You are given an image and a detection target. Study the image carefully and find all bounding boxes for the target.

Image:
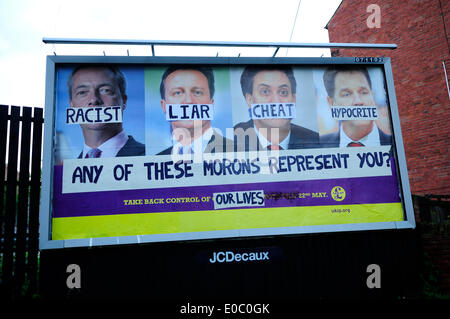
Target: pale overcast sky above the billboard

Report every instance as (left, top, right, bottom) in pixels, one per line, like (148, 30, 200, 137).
(0, 0, 341, 107)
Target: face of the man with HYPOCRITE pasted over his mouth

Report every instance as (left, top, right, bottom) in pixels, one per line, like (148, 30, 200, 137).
(328, 71, 375, 129)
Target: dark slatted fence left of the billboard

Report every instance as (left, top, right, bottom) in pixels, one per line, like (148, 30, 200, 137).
(0, 105, 44, 300)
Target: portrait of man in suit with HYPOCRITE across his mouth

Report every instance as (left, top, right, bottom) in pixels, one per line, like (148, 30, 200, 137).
(320, 66, 392, 147)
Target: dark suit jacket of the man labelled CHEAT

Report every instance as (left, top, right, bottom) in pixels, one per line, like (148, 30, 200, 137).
(234, 120, 320, 152)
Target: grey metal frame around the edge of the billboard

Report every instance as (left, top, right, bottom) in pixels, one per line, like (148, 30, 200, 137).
(39, 56, 415, 249)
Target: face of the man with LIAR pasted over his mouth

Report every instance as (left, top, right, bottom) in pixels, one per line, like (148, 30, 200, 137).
(161, 70, 214, 129)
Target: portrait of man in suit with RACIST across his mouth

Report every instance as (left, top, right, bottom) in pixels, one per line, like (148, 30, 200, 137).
(67, 65, 145, 158)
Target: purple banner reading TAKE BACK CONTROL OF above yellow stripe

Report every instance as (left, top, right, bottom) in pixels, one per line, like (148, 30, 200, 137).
(53, 162, 401, 217)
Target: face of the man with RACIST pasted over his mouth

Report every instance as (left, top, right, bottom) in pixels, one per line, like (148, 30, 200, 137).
(70, 68, 127, 129)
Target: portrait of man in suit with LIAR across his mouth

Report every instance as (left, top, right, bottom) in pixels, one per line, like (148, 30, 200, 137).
(157, 65, 233, 155)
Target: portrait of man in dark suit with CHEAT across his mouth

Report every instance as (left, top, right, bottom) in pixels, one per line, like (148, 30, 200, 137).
(234, 65, 319, 151)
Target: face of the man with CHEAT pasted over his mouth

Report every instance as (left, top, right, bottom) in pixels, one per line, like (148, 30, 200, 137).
(245, 71, 296, 128)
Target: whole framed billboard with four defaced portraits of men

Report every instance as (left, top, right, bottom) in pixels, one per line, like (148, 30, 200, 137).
(40, 56, 415, 249)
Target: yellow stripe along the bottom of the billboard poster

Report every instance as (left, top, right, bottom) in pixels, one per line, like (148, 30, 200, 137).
(52, 203, 404, 240)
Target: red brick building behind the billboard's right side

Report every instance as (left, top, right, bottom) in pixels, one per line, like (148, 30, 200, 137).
(326, 0, 450, 195)
